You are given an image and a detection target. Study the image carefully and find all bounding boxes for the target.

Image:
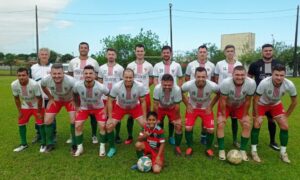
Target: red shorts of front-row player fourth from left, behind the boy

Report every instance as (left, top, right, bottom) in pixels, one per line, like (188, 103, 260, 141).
(112, 104, 143, 121)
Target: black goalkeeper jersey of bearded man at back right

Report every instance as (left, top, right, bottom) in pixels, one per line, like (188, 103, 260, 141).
(248, 59, 281, 85)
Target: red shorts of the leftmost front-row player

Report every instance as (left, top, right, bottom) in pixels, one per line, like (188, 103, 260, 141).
(18, 109, 45, 125)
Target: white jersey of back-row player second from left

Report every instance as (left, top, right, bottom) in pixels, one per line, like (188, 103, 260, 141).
(68, 57, 99, 81)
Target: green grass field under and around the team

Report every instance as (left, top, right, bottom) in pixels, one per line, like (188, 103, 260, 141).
(0, 76, 300, 179)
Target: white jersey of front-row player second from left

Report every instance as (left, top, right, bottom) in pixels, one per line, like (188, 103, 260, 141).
(41, 75, 76, 102)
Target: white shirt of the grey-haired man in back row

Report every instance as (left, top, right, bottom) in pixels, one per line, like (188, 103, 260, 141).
(30, 63, 52, 99)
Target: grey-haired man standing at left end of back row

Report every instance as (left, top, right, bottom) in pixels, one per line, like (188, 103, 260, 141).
(29, 48, 56, 143)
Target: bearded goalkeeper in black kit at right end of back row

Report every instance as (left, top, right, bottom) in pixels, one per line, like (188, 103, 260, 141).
(248, 44, 280, 151)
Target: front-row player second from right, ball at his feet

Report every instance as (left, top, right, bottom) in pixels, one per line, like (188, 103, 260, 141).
(217, 66, 256, 161)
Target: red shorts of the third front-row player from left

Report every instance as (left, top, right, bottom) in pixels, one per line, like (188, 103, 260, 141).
(75, 108, 107, 122)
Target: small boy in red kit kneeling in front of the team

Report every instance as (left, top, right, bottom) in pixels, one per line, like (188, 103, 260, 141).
(131, 112, 165, 173)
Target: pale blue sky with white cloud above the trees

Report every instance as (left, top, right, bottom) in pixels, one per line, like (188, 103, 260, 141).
(0, 0, 300, 56)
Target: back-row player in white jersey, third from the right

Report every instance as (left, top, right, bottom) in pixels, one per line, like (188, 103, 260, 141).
(185, 45, 215, 144)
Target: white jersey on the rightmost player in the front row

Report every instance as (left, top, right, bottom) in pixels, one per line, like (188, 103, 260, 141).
(256, 77, 297, 105)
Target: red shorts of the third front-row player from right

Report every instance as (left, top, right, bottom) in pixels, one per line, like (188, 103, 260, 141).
(185, 109, 214, 129)
